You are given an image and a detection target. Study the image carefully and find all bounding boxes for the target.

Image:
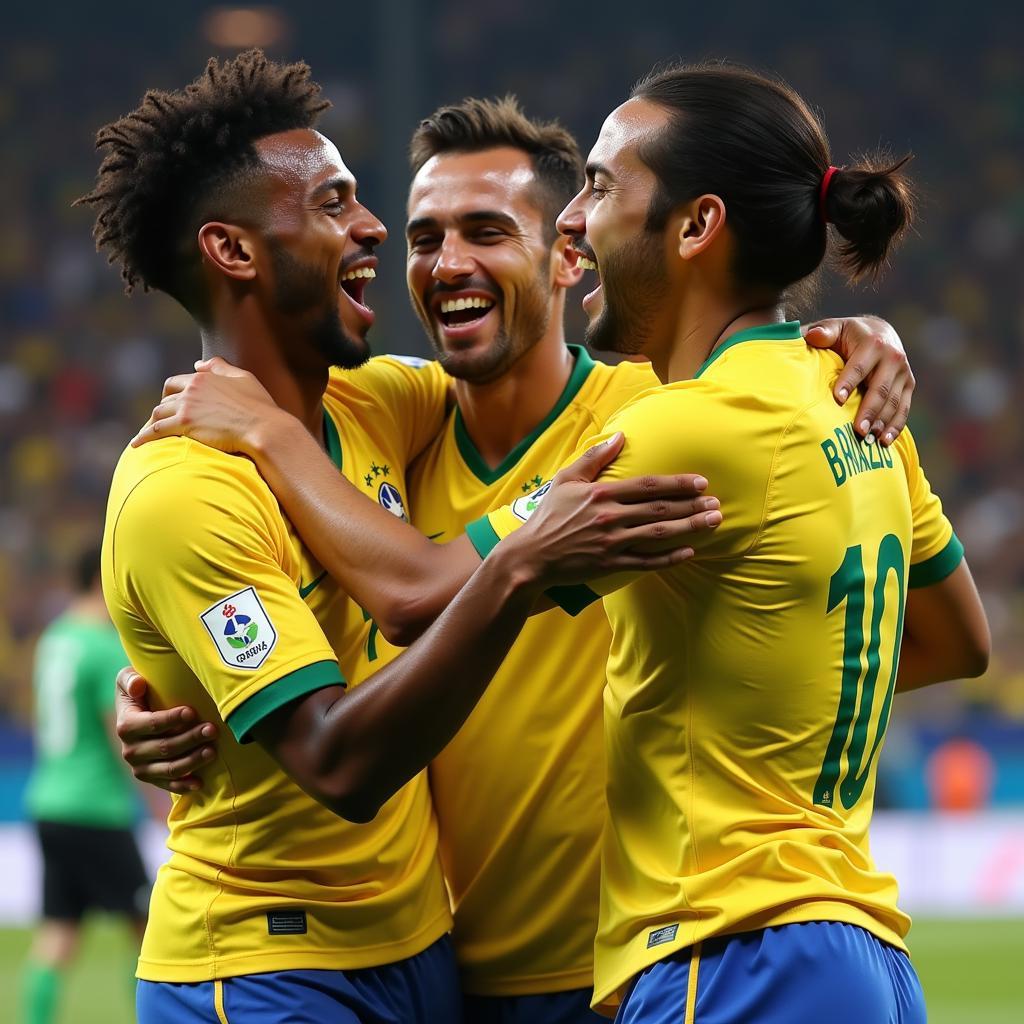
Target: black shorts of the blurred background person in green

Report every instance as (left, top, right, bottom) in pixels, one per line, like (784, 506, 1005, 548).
(36, 821, 150, 921)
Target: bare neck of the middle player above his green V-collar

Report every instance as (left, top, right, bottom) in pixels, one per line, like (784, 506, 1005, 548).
(455, 329, 573, 469)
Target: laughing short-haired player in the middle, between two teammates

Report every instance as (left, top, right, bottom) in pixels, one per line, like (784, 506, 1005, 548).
(117, 100, 921, 1022)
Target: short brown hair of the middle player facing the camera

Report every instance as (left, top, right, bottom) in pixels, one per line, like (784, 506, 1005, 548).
(409, 95, 584, 241)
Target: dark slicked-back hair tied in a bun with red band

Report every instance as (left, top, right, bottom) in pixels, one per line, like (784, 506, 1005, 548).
(631, 63, 913, 291)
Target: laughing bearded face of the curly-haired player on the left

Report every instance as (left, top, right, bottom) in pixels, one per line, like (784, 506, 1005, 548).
(256, 129, 387, 368)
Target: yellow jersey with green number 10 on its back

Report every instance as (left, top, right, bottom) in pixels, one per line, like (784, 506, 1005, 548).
(474, 323, 963, 1007)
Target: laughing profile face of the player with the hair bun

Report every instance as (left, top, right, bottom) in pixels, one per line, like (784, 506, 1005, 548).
(558, 99, 671, 356)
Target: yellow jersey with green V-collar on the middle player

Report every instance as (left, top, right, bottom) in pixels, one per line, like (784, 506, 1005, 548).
(399, 346, 656, 995)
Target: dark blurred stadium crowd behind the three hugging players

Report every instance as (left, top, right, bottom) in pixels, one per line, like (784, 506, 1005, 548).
(0, 0, 1024, 820)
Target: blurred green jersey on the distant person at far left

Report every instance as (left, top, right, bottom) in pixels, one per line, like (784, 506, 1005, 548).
(27, 612, 137, 828)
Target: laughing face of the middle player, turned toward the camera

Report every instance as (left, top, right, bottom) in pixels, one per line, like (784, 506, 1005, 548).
(407, 147, 554, 383)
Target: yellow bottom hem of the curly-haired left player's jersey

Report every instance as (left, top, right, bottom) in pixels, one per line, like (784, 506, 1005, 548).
(135, 910, 452, 984)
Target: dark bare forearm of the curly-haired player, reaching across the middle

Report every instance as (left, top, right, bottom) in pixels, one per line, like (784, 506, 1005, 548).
(299, 550, 538, 820)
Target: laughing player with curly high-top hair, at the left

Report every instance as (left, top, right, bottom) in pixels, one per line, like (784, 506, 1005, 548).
(82, 51, 707, 1024)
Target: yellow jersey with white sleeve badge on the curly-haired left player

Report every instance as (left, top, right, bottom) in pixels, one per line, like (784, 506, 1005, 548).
(102, 359, 452, 982)
